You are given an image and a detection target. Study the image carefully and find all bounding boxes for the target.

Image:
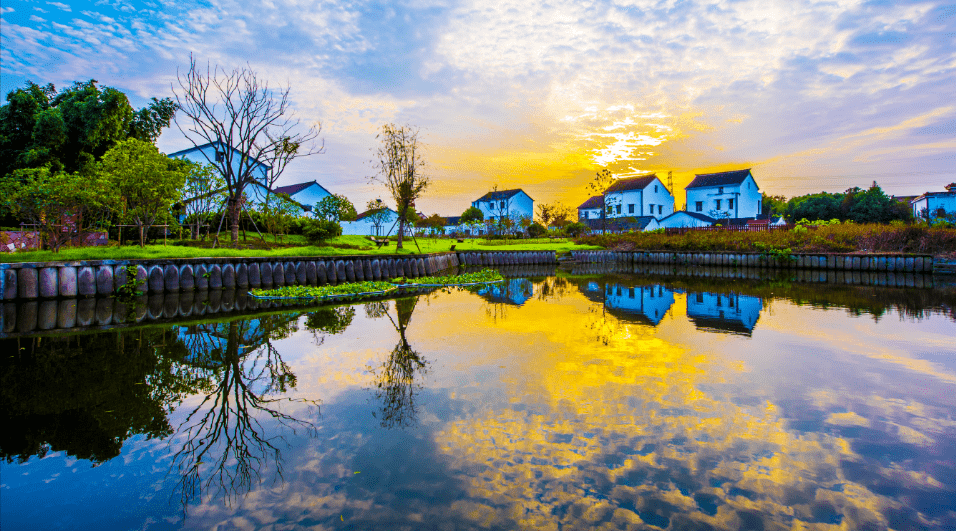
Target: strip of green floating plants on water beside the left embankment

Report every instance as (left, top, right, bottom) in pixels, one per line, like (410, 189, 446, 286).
(249, 269, 504, 300)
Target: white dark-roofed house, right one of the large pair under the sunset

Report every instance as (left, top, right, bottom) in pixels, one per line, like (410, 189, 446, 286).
(685, 168, 763, 219)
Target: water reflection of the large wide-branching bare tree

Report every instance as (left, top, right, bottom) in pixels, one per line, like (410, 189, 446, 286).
(171, 314, 316, 511)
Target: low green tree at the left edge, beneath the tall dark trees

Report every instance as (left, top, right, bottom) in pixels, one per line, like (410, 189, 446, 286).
(0, 168, 114, 252)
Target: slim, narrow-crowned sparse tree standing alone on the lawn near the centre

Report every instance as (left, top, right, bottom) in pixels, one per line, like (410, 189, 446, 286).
(372, 124, 429, 250)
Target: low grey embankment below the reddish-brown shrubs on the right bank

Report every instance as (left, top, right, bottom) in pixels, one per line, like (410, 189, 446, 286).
(571, 251, 942, 273)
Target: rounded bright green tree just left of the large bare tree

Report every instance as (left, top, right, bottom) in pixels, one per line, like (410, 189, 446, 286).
(99, 138, 189, 247)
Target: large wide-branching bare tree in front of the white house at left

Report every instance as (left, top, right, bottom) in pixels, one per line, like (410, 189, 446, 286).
(173, 56, 324, 244)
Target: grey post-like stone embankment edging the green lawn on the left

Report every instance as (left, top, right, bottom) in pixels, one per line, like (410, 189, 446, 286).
(0, 251, 556, 300)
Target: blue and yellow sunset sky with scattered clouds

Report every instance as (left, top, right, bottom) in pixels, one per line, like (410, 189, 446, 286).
(0, 0, 956, 215)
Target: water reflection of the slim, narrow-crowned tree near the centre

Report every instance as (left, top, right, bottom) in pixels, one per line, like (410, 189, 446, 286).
(366, 297, 428, 428)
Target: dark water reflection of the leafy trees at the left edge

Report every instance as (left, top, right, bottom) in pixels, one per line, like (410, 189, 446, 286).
(0, 327, 203, 466)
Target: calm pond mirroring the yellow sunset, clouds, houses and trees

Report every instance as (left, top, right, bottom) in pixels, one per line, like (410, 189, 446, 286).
(0, 269, 956, 530)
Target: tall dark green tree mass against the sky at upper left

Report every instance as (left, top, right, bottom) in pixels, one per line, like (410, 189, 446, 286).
(0, 80, 176, 175)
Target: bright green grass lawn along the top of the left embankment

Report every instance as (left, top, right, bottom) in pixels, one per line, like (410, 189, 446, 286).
(0, 235, 601, 262)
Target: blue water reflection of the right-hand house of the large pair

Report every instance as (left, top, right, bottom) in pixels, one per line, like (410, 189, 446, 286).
(687, 291, 763, 336)
